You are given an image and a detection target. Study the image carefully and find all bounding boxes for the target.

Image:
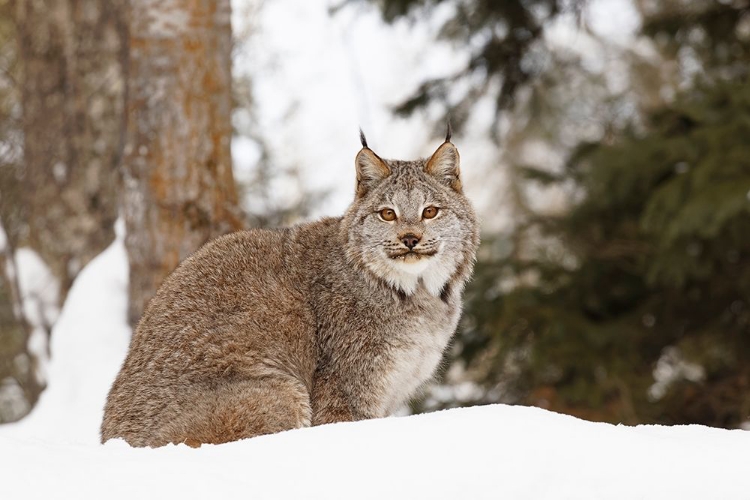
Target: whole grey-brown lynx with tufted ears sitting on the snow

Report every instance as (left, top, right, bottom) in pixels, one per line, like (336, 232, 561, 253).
(101, 127, 479, 447)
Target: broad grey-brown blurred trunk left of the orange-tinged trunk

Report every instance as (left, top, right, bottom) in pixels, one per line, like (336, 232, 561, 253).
(15, 0, 124, 303)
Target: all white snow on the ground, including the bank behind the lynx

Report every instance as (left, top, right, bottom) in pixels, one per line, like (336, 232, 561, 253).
(0, 201, 750, 500)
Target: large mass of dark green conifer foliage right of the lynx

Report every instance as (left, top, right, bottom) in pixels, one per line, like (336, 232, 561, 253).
(464, 82, 750, 427)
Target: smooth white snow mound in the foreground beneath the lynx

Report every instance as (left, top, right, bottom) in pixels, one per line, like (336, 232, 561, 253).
(0, 405, 750, 500)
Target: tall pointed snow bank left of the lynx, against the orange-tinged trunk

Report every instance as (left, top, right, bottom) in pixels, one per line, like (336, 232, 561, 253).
(5, 219, 130, 443)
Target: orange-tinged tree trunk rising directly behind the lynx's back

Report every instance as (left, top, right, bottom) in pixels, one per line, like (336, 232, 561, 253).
(124, 0, 240, 324)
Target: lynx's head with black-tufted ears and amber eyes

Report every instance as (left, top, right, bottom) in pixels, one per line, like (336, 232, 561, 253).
(344, 126, 479, 296)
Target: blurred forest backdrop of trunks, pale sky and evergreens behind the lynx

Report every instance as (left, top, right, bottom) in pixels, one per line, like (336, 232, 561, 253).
(0, 0, 750, 428)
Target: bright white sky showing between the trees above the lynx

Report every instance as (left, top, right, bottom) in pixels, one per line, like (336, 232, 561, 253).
(232, 0, 638, 229)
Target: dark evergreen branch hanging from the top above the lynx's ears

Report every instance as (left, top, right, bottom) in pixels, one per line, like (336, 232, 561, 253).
(358, 0, 586, 132)
